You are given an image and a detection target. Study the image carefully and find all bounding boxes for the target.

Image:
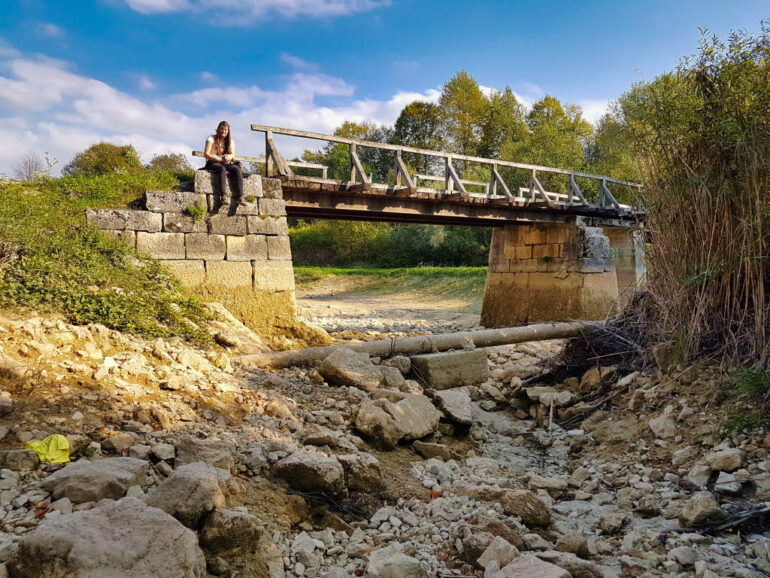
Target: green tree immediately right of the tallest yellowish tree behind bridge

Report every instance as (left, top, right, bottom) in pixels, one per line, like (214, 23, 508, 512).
(479, 86, 527, 158)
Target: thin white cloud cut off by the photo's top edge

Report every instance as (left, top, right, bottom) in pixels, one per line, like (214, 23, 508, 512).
(125, 0, 391, 21)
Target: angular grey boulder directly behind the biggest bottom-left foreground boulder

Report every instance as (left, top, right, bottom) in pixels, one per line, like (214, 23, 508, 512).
(144, 462, 230, 529)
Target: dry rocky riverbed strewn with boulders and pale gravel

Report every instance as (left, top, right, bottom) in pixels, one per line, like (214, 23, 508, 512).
(0, 304, 770, 578)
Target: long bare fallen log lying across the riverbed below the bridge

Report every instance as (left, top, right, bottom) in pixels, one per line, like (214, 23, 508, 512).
(237, 323, 596, 369)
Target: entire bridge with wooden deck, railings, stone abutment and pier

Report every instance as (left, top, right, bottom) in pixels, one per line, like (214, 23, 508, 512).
(86, 125, 644, 327)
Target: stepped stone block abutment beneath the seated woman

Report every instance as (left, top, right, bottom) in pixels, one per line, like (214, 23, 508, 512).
(86, 170, 294, 301)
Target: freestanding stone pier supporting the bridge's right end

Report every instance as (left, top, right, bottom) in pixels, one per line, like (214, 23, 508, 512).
(481, 217, 644, 327)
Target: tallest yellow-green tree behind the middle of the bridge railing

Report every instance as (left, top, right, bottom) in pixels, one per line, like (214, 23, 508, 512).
(439, 70, 489, 155)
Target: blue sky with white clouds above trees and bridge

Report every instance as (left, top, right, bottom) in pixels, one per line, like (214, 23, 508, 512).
(0, 0, 770, 175)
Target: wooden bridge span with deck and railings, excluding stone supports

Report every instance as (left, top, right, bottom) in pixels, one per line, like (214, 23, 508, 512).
(193, 124, 640, 227)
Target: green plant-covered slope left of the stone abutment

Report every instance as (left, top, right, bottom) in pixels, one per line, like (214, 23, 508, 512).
(0, 171, 210, 345)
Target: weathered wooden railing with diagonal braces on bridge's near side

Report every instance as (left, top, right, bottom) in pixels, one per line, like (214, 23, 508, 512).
(251, 124, 641, 211)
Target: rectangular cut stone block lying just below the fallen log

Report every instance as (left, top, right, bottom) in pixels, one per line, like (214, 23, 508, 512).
(411, 349, 489, 389)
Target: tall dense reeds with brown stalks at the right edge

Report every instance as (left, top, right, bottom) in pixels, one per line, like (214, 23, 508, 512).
(619, 27, 770, 364)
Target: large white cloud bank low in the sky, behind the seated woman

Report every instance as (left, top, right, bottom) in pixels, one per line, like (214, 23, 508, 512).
(0, 55, 439, 172)
